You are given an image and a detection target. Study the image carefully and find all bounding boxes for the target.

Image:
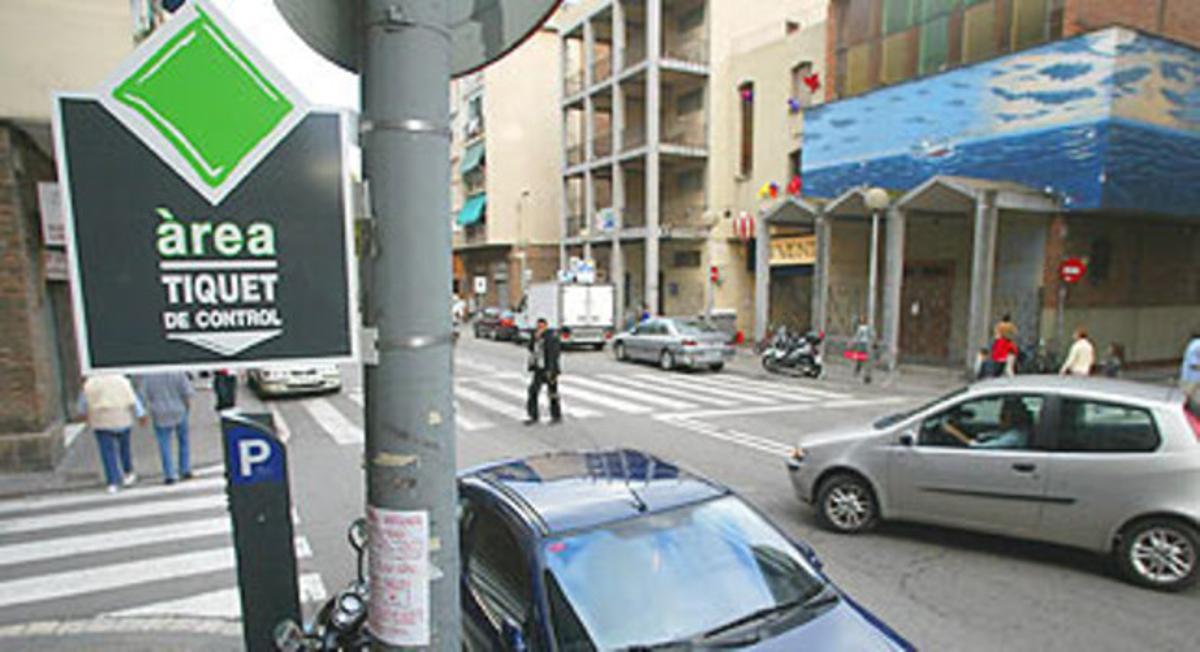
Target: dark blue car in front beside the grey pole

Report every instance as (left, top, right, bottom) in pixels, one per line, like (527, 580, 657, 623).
(458, 450, 913, 652)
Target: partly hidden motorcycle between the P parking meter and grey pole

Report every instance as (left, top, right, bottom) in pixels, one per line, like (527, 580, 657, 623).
(275, 519, 372, 652)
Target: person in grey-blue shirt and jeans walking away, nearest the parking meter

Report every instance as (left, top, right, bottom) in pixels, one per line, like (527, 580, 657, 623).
(137, 371, 196, 484)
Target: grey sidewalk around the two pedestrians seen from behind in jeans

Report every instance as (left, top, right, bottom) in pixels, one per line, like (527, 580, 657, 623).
(0, 378, 265, 498)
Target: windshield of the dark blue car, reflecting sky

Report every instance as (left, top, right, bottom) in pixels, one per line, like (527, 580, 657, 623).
(545, 496, 824, 651)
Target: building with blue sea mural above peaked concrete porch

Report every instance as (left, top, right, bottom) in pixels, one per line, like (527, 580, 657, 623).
(802, 0, 1200, 367)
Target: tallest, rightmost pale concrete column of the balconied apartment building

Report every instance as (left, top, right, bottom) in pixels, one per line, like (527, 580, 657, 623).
(644, 0, 662, 313)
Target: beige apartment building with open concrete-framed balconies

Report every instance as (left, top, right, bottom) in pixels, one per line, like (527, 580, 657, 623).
(559, 0, 824, 328)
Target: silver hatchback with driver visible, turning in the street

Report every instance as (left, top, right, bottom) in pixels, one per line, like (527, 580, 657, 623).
(787, 376, 1200, 591)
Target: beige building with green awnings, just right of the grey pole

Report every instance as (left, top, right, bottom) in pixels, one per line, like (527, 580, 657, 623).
(450, 23, 562, 309)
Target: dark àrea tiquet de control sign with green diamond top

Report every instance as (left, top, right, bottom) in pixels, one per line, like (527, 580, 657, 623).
(55, 0, 358, 372)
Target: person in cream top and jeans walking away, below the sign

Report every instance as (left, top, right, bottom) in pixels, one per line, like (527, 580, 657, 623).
(78, 373, 145, 494)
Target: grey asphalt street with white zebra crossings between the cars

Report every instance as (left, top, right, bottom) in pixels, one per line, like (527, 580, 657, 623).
(0, 336, 1200, 650)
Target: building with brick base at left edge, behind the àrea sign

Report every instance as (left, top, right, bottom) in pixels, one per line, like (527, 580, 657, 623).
(0, 0, 133, 469)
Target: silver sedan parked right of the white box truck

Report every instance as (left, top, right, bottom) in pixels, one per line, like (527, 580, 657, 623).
(612, 317, 734, 371)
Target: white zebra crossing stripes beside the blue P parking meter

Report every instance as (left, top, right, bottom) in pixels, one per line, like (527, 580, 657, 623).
(0, 477, 324, 617)
